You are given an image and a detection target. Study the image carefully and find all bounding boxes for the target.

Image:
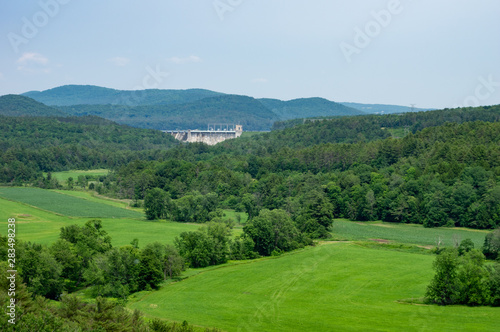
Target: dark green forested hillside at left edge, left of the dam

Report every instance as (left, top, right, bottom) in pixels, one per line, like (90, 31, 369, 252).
(0, 116, 179, 183)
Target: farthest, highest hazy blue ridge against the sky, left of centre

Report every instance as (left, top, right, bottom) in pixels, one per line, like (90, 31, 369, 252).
(23, 85, 221, 106)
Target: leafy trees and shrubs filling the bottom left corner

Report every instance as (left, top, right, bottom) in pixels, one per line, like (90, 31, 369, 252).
(0, 220, 226, 332)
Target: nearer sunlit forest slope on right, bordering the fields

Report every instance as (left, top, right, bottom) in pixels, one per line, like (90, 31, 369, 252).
(115, 122, 500, 229)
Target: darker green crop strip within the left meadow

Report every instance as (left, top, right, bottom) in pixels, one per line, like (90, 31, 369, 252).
(0, 188, 144, 218)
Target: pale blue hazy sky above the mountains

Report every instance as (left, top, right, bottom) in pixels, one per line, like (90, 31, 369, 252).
(0, 0, 500, 108)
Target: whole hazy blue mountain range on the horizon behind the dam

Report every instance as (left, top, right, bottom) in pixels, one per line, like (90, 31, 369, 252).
(11, 85, 434, 131)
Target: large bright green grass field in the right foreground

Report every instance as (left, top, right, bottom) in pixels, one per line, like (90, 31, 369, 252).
(129, 243, 500, 331)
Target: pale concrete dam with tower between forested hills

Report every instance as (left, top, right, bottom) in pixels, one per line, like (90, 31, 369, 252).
(162, 125, 243, 145)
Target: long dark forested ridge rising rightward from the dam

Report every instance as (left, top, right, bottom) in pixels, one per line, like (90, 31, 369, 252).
(215, 105, 500, 154)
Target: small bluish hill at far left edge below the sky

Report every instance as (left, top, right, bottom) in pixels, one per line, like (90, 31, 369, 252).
(0, 95, 66, 116)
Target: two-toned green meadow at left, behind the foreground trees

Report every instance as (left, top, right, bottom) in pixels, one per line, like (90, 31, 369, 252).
(0, 188, 199, 246)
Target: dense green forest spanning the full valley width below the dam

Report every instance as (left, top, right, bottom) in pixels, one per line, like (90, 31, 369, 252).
(0, 106, 500, 231)
